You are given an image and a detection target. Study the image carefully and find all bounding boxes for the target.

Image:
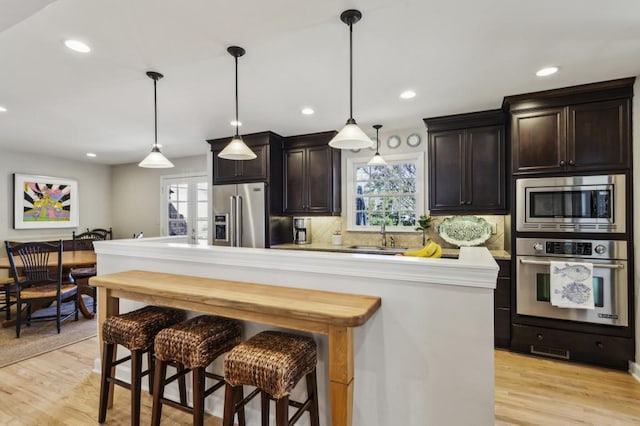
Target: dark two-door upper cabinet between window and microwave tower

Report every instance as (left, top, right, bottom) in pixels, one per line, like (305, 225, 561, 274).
(424, 110, 507, 214)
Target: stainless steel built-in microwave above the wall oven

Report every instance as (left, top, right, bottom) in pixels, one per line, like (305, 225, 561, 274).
(516, 175, 626, 233)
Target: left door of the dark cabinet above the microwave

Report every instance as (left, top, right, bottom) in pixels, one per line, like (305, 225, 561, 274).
(511, 108, 567, 173)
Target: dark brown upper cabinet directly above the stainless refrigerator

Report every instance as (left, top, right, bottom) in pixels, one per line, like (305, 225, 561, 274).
(207, 132, 282, 186)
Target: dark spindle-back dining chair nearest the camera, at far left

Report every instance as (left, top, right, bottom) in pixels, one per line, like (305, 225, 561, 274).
(5, 241, 78, 337)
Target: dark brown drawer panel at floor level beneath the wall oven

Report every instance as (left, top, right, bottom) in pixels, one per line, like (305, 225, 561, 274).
(511, 324, 635, 370)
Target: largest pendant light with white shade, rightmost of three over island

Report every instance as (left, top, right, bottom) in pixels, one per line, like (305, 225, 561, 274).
(329, 9, 373, 149)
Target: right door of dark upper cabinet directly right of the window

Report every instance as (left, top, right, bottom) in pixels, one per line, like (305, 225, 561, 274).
(464, 126, 506, 212)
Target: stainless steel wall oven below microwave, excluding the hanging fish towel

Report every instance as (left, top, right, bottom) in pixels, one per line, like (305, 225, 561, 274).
(516, 238, 629, 327)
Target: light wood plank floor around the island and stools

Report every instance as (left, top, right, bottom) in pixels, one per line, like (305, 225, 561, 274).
(0, 338, 640, 426)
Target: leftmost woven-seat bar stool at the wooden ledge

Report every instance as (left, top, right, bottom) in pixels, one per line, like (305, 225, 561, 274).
(98, 306, 186, 426)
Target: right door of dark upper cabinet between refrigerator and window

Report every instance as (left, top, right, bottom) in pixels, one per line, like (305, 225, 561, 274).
(305, 145, 333, 213)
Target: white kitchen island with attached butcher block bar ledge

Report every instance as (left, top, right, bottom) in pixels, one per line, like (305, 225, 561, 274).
(91, 237, 498, 426)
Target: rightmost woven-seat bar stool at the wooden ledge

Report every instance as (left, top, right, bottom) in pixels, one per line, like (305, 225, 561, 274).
(222, 331, 320, 426)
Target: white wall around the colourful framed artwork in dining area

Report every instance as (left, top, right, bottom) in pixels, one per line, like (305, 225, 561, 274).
(0, 150, 112, 248)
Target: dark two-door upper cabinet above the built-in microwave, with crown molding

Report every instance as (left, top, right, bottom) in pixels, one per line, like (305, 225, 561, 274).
(504, 78, 635, 174)
